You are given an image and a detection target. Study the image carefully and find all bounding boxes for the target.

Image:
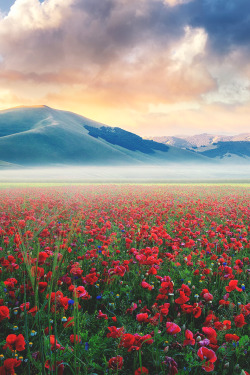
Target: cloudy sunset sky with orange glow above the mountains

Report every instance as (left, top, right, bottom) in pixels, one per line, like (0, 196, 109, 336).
(0, 0, 250, 136)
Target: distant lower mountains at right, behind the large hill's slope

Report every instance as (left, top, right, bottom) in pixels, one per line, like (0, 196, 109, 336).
(148, 133, 250, 161)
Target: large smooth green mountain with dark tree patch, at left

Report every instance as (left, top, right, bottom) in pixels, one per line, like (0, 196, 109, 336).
(0, 106, 209, 166)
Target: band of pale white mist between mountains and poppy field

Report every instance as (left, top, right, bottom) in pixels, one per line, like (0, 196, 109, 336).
(0, 163, 250, 183)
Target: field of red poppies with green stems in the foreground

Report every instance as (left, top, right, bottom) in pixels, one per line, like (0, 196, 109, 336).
(0, 185, 250, 375)
